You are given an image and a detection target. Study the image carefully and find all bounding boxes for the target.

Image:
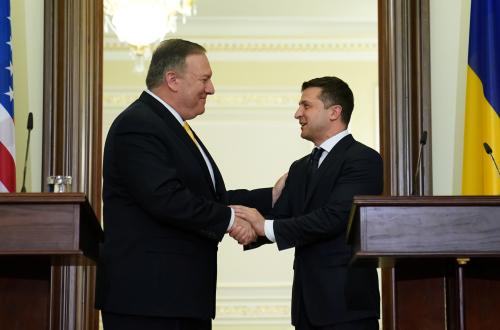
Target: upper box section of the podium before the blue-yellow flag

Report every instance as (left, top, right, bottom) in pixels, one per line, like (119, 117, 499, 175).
(347, 196, 500, 260)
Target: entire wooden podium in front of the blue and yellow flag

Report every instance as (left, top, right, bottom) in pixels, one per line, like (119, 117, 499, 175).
(348, 196, 500, 330)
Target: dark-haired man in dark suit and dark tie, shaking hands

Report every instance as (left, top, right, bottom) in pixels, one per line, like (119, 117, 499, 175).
(231, 77, 382, 330)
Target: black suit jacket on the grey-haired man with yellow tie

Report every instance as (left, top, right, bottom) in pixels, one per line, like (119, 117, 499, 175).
(96, 92, 272, 319)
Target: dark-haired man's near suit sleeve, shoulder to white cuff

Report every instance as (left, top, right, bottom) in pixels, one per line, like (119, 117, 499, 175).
(274, 152, 382, 250)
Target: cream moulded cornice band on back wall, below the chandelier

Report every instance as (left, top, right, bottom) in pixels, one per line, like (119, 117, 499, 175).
(104, 16, 378, 61)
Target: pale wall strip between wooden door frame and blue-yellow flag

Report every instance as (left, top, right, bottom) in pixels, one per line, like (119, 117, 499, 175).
(430, 0, 470, 195)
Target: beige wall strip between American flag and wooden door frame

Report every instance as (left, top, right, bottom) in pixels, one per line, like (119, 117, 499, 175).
(10, 0, 43, 191)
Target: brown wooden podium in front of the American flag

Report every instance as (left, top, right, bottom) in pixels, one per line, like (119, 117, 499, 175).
(0, 193, 102, 330)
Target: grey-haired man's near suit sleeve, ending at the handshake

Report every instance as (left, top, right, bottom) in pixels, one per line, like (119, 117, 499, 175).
(112, 111, 231, 240)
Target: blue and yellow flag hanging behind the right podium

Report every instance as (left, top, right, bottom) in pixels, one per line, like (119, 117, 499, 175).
(462, 0, 500, 195)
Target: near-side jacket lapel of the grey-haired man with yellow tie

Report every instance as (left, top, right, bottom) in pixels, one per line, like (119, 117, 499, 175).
(139, 92, 220, 195)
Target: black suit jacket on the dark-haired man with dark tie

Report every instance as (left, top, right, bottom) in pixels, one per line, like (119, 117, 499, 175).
(256, 135, 383, 326)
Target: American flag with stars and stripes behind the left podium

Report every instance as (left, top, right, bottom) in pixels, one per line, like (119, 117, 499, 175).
(0, 0, 16, 192)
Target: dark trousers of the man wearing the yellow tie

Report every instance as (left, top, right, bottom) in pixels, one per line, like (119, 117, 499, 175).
(101, 312, 212, 330)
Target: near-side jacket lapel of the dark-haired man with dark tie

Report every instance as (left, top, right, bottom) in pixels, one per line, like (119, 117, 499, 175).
(304, 135, 354, 206)
